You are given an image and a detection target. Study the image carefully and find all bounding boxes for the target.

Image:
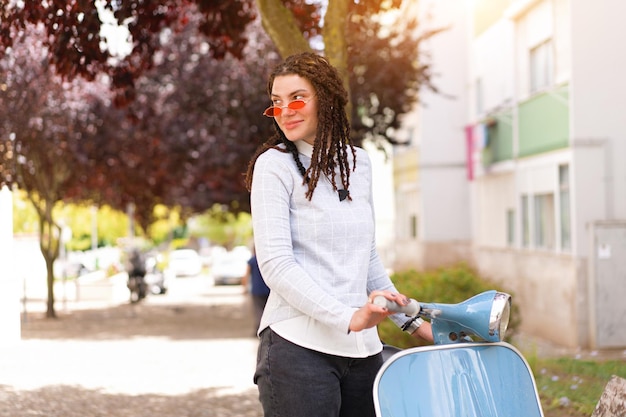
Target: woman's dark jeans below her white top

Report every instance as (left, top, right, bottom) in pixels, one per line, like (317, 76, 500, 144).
(254, 328, 383, 417)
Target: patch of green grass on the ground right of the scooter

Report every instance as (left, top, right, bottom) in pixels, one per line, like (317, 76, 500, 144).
(529, 358, 626, 417)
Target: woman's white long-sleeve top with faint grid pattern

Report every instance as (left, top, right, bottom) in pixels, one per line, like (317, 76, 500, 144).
(251, 141, 403, 357)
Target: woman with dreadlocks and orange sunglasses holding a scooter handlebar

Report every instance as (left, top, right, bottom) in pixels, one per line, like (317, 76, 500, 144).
(247, 53, 432, 417)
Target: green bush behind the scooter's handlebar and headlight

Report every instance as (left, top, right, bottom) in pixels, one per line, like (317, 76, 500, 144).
(378, 264, 521, 348)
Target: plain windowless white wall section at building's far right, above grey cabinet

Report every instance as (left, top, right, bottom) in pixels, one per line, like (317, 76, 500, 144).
(570, 0, 626, 253)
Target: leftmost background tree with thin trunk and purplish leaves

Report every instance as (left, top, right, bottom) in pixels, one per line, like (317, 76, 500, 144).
(0, 27, 109, 317)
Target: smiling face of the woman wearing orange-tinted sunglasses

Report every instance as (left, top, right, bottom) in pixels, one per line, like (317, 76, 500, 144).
(271, 74, 318, 145)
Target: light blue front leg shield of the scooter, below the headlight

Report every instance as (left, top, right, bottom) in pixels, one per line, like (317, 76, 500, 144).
(374, 342, 543, 417)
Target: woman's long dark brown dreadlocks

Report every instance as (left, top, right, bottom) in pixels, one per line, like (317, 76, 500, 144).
(246, 52, 356, 200)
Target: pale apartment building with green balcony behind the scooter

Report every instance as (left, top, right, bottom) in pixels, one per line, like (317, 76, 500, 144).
(394, 0, 626, 348)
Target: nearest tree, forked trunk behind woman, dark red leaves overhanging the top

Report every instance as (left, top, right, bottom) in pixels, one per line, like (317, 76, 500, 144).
(0, 0, 438, 148)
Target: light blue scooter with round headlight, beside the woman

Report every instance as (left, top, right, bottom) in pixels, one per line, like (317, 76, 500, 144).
(374, 291, 543, 417)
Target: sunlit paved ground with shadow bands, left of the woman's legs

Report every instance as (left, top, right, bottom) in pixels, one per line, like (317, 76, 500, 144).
(0, 277, 262, 417)
